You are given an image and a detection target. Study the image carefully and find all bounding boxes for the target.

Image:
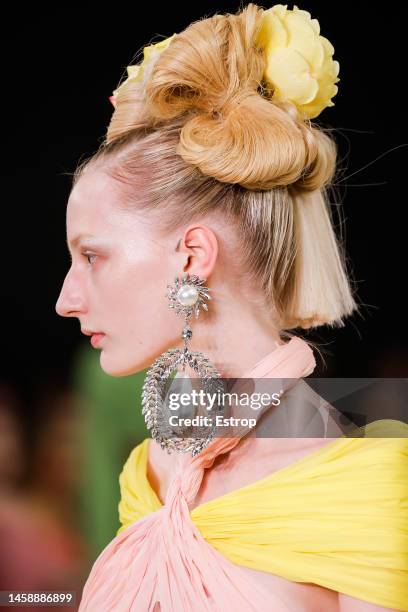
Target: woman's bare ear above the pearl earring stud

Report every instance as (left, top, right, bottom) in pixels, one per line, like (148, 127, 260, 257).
(176, 223, 219, 278)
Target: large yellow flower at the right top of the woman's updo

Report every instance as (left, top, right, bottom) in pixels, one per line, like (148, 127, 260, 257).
(257, 4, 340, 119)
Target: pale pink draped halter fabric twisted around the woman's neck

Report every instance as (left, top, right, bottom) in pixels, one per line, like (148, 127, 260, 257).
(79, 337, 315, 612)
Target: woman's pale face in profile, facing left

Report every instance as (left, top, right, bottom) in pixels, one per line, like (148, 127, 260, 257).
(56, 171, 183, 376)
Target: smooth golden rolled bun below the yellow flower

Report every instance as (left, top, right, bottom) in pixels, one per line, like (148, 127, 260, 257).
(177, 91, 335, 189)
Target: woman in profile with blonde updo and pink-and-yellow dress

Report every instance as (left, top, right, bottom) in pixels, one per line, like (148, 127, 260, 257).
(57, 4, 408, 612)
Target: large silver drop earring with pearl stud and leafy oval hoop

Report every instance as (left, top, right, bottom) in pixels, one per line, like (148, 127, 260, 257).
(142, 274, 224, 457)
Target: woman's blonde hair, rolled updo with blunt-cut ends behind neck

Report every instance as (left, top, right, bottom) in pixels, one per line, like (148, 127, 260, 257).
(74, 4, 357, 330)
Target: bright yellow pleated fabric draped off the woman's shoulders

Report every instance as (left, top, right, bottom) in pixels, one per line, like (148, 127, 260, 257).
(117, 419, 408, 612)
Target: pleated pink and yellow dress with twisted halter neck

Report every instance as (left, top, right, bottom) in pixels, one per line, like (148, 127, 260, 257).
(79, 337, 408, 612)
